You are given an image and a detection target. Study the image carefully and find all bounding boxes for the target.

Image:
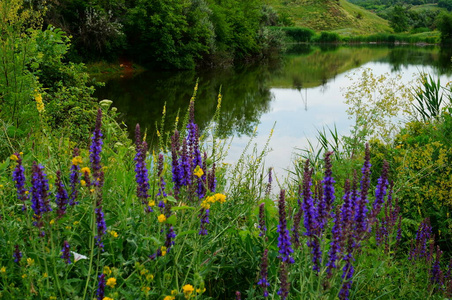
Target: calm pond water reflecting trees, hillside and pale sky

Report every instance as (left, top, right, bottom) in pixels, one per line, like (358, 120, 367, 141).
(96, 47, 452, 175)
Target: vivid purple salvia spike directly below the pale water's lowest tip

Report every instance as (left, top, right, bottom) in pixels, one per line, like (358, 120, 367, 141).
(277, 190, 295, 264)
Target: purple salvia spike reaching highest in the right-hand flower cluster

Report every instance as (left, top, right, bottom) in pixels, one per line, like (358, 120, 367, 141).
(355, 144, 371, 242)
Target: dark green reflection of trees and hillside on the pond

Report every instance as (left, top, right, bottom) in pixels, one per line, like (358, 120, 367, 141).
(96, 45, 452, 144)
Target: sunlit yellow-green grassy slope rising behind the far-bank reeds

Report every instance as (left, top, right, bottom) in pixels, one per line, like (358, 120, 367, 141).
(269, 0, 392, 35)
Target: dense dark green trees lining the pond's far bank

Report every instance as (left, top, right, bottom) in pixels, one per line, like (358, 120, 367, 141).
(45, 0, 286, 68)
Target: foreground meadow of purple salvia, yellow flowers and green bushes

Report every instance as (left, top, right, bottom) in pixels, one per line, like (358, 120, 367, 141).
(0, 0, 452, 300)
